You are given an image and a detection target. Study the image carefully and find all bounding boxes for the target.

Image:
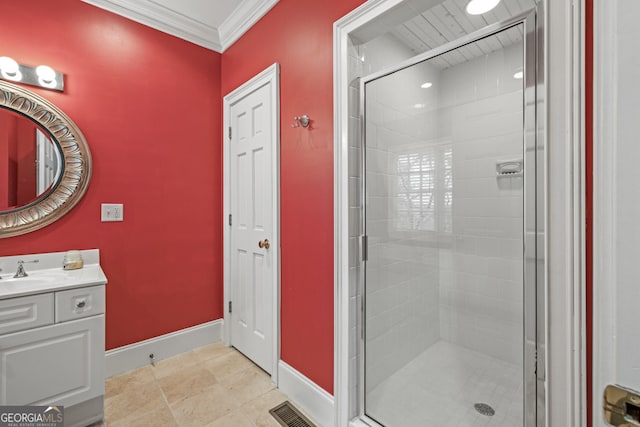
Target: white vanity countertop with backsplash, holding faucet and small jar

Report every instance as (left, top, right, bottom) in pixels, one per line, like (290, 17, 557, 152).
(0, 249, 107, 300)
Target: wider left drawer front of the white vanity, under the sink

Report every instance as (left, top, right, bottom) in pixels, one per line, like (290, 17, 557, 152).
(0, 293, 53, 334)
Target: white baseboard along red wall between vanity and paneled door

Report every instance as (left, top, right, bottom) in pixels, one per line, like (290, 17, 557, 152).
(105, 319, 223, 378)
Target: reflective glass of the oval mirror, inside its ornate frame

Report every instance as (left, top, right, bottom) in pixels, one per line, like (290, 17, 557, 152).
(0, 108, 63, 211)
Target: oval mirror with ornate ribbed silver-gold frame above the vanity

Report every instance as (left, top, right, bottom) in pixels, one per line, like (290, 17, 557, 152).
(0, 81, 91, 238)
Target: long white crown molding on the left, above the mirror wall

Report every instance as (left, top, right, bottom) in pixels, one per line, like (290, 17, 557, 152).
(82, 0, 222, 53)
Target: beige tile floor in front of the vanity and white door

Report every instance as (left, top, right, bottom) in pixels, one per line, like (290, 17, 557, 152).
(92, 343, 287, 427)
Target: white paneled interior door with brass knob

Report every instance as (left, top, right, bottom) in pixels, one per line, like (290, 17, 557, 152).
(228, 77, 278, 373)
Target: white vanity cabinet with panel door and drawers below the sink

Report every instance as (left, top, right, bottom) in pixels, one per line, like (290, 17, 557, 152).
(0, 251, 106, 426)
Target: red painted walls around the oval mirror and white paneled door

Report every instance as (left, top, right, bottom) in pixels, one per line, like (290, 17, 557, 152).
(0, 0, 364, 398)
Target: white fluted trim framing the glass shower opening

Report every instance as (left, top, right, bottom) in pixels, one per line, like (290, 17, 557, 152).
(334, 0, 585, 426)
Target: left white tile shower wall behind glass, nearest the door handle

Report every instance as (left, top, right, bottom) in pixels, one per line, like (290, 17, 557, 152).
(365, 47, 440, 392)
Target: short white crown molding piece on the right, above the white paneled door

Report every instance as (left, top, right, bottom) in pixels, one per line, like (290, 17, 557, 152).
(218, 0, 278, 52)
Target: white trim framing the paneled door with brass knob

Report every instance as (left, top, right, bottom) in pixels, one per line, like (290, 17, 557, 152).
(222, 63, 280, 384)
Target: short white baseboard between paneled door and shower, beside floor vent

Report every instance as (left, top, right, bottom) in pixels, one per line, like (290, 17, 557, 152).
(278, 360, 335, 427)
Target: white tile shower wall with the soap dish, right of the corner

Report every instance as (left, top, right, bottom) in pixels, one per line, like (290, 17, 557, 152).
(440, 42, 523, 365)
